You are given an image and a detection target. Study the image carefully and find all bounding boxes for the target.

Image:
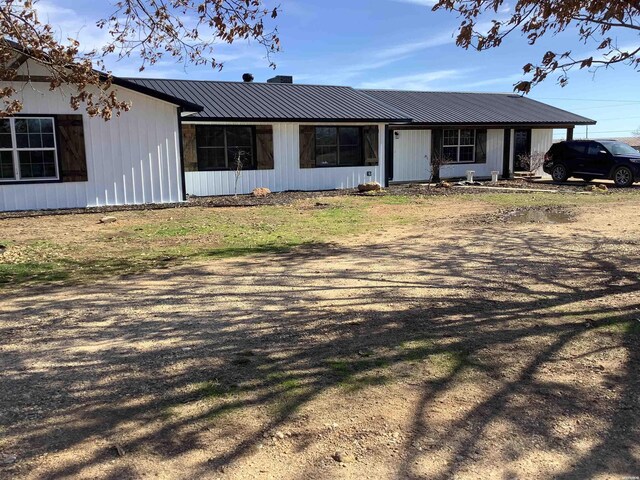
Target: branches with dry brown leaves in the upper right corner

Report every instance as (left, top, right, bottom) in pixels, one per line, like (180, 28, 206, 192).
(433, 0, 640, 93)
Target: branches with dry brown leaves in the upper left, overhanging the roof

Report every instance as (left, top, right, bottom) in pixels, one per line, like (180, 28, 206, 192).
(0, 0, 280, 120)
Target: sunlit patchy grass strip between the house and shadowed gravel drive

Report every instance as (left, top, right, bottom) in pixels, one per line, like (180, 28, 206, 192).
(0, 193, 632, 289)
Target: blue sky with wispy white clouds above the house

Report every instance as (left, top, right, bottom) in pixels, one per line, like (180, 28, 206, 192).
(33, 0, 640, 138)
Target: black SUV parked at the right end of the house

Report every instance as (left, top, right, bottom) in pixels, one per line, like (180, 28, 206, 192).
(543, 140, 640, 187)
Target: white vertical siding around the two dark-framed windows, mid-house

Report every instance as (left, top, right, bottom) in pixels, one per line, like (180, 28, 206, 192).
(184, 121, 385, 196)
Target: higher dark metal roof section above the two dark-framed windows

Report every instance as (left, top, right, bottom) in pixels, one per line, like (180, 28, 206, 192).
(127, 78, 411, 123)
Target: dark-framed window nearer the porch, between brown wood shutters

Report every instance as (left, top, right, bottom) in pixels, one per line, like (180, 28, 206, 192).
(315, 127, 364, 167)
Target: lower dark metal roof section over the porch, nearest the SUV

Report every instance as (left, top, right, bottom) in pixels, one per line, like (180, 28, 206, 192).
(361, 90, 596, 125)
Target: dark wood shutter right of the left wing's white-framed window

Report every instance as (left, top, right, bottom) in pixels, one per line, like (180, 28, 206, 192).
(55, 115, 88, 182)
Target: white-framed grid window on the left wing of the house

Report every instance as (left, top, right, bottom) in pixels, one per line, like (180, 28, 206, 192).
(0, 117, 59, 182)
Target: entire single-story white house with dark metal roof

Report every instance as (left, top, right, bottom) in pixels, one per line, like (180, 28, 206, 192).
(0, 60, 595, 211)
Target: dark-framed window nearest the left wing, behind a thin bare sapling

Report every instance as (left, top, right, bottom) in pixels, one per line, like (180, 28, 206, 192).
(196, 125, 256, 171)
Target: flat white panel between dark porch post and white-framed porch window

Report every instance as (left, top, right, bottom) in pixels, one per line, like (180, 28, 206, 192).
(393, 130, 431, 182)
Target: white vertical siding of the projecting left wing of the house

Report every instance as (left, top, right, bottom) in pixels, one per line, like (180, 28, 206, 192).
(0, 82, 183, 211)
